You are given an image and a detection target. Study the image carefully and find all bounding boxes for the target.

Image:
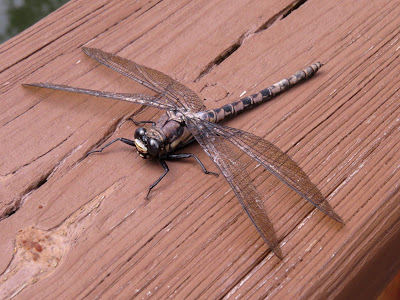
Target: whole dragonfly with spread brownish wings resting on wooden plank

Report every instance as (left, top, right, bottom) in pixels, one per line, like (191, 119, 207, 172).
(24, 47, 344, 259)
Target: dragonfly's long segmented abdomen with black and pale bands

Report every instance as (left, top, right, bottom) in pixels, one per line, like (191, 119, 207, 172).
(197, 62, 322, 123)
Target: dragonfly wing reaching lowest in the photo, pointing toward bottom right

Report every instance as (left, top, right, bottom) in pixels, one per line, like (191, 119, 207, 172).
(187, 118, 283, 259)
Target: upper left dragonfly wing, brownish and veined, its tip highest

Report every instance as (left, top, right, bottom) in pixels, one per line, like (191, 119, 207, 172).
(82, 47, 204, 112)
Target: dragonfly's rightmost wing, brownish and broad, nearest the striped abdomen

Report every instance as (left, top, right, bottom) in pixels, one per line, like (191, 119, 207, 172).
(203, 122, 344, 224)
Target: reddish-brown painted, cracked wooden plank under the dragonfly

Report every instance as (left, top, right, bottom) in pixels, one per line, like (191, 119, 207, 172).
(0, 0, 400, 299)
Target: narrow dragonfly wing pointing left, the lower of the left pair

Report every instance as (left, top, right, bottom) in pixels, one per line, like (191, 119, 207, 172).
(24, 83, 175, 110)
